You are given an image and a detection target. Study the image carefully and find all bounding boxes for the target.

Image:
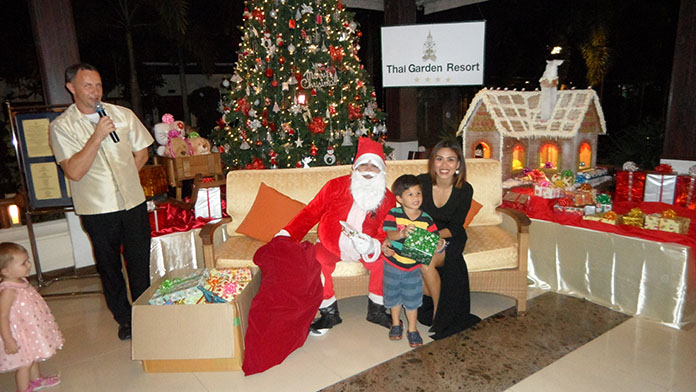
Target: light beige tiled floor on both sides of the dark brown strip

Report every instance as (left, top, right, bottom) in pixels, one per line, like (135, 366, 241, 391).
(0, 280, 696, 392)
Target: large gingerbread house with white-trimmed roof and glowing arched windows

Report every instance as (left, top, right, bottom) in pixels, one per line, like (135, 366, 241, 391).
(458, 60, 606, 179)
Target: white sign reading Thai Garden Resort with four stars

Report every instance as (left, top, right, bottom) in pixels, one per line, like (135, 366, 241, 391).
(381, 21, 486, 87)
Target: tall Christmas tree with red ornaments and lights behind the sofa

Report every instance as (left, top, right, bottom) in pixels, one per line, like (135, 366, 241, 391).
(213, 0, 386, 169)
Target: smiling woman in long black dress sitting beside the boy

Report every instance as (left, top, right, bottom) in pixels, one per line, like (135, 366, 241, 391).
(410, 141, 481, 339)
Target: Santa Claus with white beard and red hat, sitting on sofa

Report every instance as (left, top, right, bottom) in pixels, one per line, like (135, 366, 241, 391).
(279, 138, 396, 335)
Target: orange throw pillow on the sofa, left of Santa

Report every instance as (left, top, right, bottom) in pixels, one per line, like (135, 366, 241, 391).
(237, 182, 305, 242)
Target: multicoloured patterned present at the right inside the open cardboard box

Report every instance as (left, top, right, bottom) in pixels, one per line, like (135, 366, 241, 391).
(199, 267, 252, 303)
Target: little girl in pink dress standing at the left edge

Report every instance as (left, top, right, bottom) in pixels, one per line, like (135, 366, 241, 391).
(0, 242, 63, 392)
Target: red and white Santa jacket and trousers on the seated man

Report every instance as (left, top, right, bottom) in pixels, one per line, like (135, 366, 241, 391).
(285, 175, 396, 304)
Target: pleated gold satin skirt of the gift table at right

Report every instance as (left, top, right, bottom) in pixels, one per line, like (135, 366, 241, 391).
(528, 219, 696, 328)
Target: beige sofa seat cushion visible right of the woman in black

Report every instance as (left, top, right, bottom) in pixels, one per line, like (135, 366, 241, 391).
(464, 226, 518, 272)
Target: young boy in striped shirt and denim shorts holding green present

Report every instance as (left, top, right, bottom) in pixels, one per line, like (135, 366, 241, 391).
(382, 174, 445, 347)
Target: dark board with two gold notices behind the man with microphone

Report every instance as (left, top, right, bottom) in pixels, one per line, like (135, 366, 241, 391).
(8, 105, 72, 211)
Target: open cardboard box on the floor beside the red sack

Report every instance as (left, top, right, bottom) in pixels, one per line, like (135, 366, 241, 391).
(131, 268, 261, 373)
